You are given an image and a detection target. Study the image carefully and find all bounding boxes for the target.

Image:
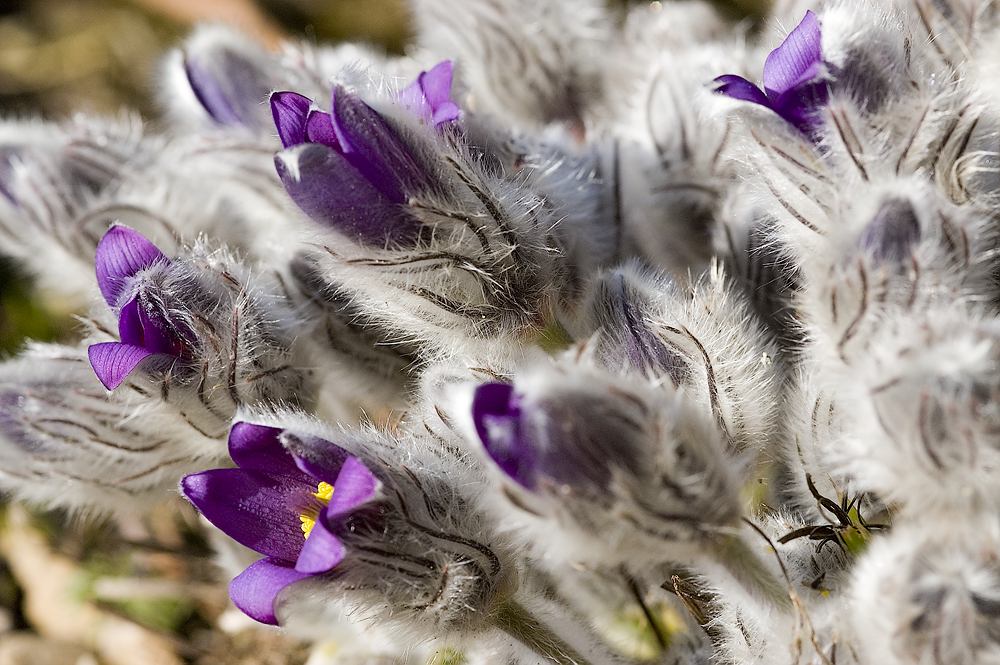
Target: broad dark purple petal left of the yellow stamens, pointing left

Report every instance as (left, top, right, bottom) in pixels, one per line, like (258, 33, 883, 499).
(181, 469, 316, 562)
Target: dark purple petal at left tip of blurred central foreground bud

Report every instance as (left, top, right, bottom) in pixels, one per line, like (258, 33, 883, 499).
(472, 383, 537, 489)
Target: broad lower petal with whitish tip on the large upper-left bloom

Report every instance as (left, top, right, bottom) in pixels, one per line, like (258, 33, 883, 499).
(274, 144, 420, 245)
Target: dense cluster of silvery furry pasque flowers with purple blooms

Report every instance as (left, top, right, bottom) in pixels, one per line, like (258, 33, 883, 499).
(0, 0, 1000, 665)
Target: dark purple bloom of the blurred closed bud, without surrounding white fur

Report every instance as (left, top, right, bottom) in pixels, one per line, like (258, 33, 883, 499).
(472, 383, 636, 490)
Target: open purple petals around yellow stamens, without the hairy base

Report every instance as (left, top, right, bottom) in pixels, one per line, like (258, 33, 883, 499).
(181, 423, 380, 624)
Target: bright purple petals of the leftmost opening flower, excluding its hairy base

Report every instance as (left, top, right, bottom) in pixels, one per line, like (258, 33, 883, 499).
(87, 226, 190, 390)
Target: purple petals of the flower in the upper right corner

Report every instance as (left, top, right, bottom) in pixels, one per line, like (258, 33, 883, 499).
(714, 11, 830, 134)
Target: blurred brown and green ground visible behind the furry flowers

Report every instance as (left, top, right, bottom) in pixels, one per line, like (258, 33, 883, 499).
(0, 0, 766, 665)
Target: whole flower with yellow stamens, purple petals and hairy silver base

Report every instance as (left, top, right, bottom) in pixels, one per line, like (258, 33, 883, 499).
(181, 414, 516, 634)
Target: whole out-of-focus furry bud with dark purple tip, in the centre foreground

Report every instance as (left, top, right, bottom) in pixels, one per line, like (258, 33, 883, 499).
(471, 358, 741, 566)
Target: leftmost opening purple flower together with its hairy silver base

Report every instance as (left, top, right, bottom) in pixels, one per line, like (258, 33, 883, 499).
(89, 226, 309, 432)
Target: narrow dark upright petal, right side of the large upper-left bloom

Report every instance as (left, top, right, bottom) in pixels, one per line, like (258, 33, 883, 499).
(331, 87, 431, 203)
